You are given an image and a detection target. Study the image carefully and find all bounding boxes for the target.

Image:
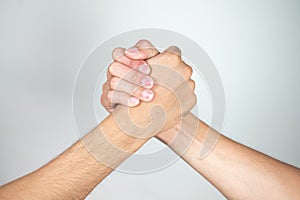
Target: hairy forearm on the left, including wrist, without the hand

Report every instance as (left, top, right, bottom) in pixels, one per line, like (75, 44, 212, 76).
(0, 117, 144, 200)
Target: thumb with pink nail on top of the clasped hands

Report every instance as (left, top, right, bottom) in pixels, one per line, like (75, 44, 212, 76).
(125, 40, 159, 60)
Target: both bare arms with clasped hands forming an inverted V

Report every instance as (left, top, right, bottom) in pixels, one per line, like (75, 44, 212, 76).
(0, 40, 300, 200)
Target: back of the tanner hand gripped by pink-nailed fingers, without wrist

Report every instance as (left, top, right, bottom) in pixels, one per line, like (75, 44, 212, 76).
(112, 58, 196, 139)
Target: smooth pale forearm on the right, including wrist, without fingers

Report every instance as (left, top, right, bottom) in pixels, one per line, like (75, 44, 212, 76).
(160, 113, 300, 199)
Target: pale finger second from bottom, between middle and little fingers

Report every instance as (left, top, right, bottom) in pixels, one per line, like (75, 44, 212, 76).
(110, 77, 154, 102)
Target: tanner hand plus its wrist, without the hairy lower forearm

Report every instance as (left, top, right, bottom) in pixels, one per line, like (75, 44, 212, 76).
(81, 48, 196, 168)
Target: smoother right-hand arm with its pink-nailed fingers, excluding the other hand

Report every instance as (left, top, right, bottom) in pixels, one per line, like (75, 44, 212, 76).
(101, 41, 300, 200)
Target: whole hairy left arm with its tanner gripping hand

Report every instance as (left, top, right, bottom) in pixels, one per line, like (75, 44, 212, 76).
(0, 44, 195, 200)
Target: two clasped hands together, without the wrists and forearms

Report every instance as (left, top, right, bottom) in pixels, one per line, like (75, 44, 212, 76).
(101, 40, 196, 142)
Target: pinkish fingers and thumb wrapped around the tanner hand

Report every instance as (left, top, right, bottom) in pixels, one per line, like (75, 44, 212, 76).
(101, 40, 159, 112)
